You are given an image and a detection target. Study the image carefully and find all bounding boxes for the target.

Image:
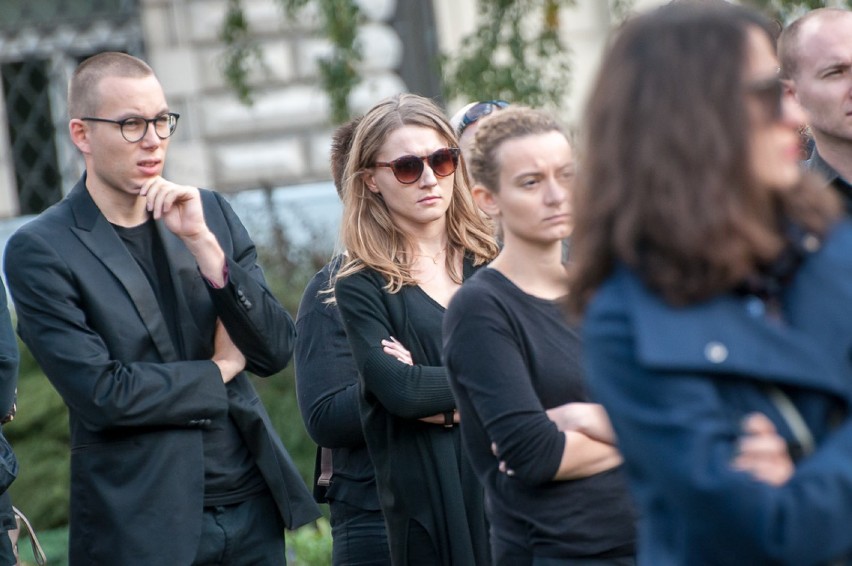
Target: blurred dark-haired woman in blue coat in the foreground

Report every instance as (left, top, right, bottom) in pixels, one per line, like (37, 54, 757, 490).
(569, 2, 852, 566)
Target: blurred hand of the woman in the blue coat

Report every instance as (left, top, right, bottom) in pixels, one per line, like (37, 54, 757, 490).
(731, 413, 795, 486)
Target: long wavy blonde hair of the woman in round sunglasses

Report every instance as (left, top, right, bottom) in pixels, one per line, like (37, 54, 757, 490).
(337, 94, 498, 293)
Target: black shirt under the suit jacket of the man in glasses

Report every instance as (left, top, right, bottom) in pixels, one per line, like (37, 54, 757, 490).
(113, 218, 266, 506)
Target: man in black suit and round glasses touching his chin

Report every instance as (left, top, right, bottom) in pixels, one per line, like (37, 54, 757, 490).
(5, 53, 319, 566)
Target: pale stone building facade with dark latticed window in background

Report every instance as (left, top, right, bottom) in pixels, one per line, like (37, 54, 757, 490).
(0, 0, 661, 222)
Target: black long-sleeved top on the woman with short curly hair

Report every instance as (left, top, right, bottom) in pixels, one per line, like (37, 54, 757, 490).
(444, 269, 635, 564)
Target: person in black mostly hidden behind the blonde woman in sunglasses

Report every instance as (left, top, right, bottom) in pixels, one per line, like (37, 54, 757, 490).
(294, 118, 390, 566)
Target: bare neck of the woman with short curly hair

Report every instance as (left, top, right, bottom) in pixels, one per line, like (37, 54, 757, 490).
(489, 235, 568, 300)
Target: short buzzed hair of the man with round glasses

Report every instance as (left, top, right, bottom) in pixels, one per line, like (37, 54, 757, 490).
(68, 51, 154, 118)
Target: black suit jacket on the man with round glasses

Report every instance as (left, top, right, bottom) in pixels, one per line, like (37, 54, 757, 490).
(5, 175, 319, 565)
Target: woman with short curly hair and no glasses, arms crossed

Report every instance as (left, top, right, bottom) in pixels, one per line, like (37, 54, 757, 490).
(444, 107, 635, 566)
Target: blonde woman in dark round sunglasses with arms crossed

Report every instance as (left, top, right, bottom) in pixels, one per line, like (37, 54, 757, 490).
(335, 94, 497, 566)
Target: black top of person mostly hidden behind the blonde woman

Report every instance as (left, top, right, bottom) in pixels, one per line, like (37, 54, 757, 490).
(294, 256, 379, 511)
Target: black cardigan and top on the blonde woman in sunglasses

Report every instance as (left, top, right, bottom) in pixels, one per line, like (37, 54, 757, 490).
(335, 261, 490, 566)
